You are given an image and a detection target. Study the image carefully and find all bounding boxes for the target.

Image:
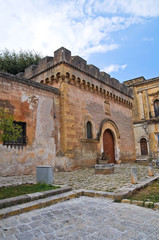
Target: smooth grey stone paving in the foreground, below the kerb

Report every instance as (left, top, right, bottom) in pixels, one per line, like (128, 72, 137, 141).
(0, 197, 159, 240)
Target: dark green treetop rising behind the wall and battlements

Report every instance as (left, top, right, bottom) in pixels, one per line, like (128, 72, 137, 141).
(0, 49, 42, 74)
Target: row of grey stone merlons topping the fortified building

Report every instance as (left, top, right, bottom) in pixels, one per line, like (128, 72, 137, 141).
(20, 47, 133, 97)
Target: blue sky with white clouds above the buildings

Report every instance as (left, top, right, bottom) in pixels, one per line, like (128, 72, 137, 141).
(0, 0, 159, 82)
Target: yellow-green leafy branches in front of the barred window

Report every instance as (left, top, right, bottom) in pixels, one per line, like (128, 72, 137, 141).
(0, 108, 22, 143)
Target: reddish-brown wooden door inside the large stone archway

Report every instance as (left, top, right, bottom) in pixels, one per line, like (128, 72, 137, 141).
(103, 129, 115, 163)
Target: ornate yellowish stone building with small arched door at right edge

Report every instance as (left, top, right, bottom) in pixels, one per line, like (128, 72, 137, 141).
(124, 77, 159, 160)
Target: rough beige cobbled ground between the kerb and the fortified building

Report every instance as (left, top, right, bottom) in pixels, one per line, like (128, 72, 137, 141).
(0, 164, 159, 192)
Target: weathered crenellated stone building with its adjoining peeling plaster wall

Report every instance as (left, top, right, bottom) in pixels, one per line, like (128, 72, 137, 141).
(0, 48, 135, 175)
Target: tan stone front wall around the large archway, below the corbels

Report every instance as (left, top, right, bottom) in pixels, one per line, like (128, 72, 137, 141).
(61, 79, 135, 168)
